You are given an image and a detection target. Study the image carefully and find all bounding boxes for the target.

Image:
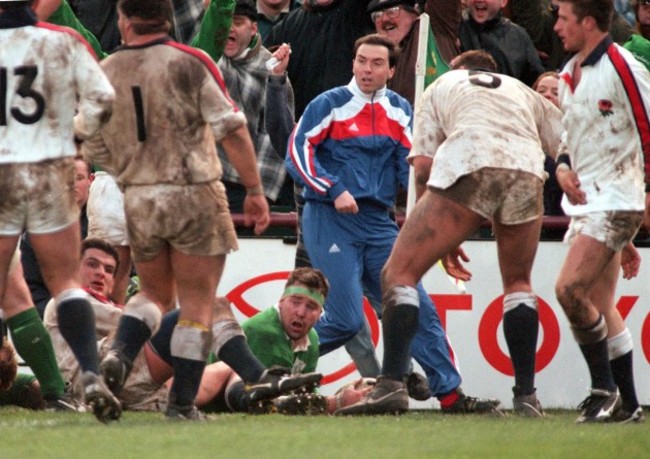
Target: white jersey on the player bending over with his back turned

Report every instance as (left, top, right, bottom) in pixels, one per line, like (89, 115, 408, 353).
(409, 70, 562, 188)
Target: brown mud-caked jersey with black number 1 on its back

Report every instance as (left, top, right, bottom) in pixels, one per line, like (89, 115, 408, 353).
(83, 37, 246, 189)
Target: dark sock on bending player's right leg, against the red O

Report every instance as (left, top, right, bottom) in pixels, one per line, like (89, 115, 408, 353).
(503, 303, 539, 395)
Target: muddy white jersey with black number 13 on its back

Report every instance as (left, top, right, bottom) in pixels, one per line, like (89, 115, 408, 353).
(0, 6, 114, 164)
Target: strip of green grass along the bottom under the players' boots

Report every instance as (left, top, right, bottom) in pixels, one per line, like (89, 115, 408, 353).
(0, 408, 650, 459)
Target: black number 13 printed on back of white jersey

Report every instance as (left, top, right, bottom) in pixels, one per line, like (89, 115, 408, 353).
(0, 65, 45, 126)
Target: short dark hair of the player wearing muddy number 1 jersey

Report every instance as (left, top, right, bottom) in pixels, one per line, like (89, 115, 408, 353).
(117, 0, 174, 35)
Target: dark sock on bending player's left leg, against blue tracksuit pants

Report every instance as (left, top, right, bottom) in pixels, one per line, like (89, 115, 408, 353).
(381, 304, 420, 381)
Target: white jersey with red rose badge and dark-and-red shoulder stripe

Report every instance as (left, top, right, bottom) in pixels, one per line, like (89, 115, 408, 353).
(559, 37, 650, 215)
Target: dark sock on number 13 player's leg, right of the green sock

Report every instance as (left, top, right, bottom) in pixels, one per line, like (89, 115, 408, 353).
(57, 298, 99, 374)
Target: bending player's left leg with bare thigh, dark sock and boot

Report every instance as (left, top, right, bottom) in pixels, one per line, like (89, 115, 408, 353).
(336, 190, 482, 415)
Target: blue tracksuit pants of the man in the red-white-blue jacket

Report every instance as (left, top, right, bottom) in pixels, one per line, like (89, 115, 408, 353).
(302, 201, 461, 396)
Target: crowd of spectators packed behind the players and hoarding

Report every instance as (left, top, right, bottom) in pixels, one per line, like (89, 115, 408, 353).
(36, 0, 650, 225)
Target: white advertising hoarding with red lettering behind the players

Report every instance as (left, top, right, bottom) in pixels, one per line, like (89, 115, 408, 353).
(218, 239, 650, 408)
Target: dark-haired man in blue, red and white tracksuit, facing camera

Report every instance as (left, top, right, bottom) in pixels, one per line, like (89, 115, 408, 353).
(285, 35, 492, 412)
